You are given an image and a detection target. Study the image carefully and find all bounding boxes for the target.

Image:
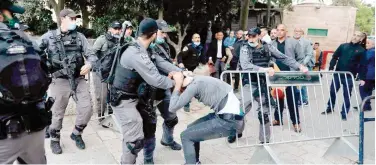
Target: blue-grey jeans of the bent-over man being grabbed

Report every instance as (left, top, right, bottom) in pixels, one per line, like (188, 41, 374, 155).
(180, 113, 236, 164)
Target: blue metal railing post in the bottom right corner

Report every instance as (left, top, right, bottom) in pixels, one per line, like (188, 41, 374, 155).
(358, 95, 375, 164)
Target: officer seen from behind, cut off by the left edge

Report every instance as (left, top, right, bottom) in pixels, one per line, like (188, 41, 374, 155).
(0, 1, 53, 164)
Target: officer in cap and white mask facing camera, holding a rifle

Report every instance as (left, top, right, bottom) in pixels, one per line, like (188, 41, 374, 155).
(39, 9, 97, 154)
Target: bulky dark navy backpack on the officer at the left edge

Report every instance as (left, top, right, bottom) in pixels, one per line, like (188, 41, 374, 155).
(0, 30, 51, 106)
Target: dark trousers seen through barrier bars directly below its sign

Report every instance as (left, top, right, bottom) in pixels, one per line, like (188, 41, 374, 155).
(274, 87, 300, 125)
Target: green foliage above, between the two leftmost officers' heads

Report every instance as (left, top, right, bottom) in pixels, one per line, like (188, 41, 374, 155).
(18, 0, 54, 35)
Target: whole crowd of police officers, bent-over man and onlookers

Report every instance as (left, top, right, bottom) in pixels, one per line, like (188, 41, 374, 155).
(0, 1, 375, 164)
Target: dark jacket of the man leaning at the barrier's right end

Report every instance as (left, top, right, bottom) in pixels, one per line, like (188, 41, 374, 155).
(329, 43, 365, 76)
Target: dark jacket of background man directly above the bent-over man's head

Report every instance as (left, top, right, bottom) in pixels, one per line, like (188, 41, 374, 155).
(177, 43, 207, 71)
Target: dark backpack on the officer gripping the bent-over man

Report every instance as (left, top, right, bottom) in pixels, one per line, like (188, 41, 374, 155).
(98, 42, 134, 84)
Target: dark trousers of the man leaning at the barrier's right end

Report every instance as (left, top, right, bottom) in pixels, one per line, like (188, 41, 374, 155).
(327, 74, 353, 119)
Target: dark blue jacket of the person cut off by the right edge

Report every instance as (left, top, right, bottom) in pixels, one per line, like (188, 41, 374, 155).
(359, 48, 375, 80)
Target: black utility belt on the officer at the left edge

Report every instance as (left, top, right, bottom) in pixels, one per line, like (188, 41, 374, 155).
(0, 97, 55, 140)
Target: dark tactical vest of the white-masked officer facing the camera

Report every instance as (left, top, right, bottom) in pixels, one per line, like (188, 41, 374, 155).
(48, 30, 85, 78)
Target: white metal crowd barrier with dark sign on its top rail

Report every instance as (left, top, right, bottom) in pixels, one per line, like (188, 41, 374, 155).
(221, 71, 359, 164)
